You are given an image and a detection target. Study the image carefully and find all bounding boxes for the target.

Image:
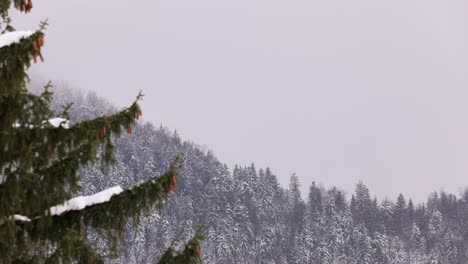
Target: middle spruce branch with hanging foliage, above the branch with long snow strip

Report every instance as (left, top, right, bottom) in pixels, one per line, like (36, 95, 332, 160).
(0, 96, 141, 221)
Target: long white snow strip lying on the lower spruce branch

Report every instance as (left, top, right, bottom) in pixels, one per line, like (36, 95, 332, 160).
(50, 186, 123, 215)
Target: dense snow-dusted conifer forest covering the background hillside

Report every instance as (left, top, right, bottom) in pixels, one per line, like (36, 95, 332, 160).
(38, 83, 468, 264)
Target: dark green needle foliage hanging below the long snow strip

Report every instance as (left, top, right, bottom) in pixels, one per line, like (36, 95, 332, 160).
(7, 161, 180, 258)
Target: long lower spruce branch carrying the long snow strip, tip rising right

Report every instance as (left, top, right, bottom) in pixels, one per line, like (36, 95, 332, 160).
(0, 159, 180, 260)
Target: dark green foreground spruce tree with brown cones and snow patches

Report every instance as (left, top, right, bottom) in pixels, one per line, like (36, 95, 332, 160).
(0, 0, 203, 264)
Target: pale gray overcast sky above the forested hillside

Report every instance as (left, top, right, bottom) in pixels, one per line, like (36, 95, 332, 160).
(15, 0, 468, 201)
